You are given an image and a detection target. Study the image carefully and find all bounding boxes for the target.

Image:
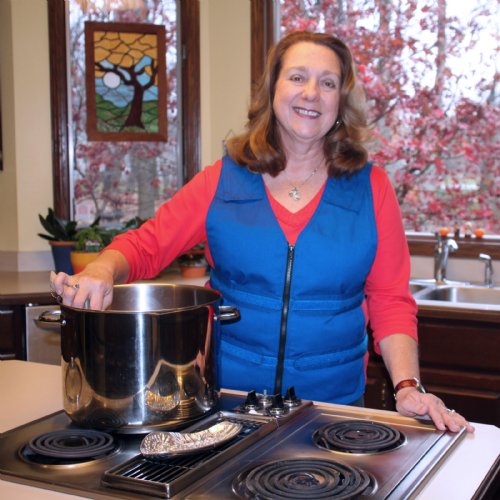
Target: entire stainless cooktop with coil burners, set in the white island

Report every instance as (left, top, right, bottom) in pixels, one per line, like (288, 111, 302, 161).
(0, 394, 464, 499)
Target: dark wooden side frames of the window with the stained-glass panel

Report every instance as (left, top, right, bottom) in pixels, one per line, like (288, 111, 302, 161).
(47, 0, 201, 219)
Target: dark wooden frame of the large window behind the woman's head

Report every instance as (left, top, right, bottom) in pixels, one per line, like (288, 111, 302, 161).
(251, 0, 500, 259)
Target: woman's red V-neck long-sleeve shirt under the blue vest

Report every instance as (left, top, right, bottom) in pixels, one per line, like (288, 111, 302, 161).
(108, 160, 417, 351)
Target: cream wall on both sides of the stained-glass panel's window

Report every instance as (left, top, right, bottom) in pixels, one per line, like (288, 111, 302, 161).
(0, 0, 250, 271)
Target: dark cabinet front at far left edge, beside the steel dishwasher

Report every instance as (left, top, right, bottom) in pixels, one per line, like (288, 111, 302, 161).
(0, 306, 25, 360)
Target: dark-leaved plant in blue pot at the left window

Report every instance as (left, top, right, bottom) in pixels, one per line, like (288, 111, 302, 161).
(38, 208, 76, 274)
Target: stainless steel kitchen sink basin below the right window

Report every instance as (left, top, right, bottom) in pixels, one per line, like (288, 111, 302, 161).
(415, 285, 500, 307)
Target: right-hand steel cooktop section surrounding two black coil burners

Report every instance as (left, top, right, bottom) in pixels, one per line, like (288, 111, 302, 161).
(179, 404, 464, 500)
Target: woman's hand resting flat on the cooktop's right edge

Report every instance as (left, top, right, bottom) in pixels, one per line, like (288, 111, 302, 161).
(396, 387, 474, 432)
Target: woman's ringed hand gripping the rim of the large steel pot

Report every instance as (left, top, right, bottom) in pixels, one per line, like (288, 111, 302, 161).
(50, 250, 129, 310)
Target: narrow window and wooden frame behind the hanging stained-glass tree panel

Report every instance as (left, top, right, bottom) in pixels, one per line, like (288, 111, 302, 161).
(48, 0, 200, 223)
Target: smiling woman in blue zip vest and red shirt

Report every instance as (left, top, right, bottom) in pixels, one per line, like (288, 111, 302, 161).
(52, 32, 473, 431)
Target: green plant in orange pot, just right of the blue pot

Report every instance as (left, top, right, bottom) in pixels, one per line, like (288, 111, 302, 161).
(71, 217, 120, 274)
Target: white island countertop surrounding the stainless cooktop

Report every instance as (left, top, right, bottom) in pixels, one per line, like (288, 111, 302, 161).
(0, 361, 500, 500)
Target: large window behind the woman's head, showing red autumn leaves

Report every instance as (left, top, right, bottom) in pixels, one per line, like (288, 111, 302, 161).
(248, 0, 500, 256)
